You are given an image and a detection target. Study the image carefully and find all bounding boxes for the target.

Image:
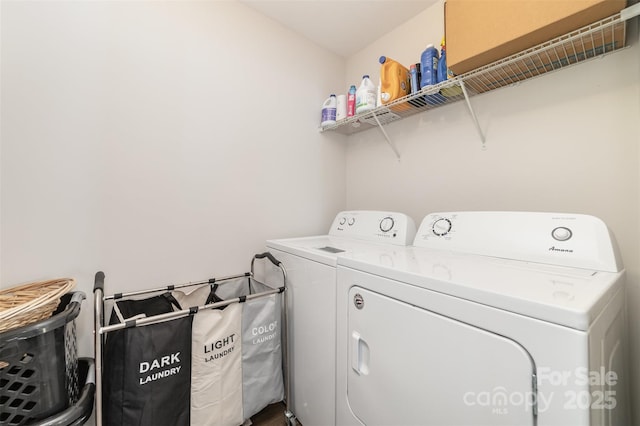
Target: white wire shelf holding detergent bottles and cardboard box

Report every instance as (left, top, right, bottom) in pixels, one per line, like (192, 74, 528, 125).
(320, 11, 627, 135)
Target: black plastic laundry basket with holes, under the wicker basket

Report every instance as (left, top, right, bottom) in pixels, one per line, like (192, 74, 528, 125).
(0, 292, 85, 426)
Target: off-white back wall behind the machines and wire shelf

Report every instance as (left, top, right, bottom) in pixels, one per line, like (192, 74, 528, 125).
(347, 3, 640, 424)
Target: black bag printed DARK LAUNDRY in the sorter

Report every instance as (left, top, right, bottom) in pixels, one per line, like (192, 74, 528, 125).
(103, 294, 193, 426)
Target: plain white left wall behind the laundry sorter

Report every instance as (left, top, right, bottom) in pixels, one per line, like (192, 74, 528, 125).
(0, 1, 345, 355)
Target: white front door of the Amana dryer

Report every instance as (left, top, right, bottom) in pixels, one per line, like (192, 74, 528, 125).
(347, 286, 536, 426)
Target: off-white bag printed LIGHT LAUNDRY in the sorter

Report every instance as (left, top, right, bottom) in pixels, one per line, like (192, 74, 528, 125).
(173, 285, 244, 426)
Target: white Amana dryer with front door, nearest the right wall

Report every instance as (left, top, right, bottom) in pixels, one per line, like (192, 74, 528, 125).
(336, 212, 629, 426)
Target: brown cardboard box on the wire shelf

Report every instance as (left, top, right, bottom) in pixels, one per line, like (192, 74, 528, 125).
(445, 0, 627, 75)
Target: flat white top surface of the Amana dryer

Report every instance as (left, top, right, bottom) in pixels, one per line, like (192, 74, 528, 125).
(338, 247, 624, 330)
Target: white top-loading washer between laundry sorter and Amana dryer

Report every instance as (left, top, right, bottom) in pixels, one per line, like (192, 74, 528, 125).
(267, 211, 416, 426)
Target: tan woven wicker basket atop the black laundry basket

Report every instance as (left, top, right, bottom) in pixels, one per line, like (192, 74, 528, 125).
(0, 278, 76, 333)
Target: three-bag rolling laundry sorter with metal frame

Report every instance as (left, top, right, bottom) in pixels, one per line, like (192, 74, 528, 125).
(94, 252, 296, 426)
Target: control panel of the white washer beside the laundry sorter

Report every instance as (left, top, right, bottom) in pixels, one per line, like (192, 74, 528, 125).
(329, 210, 416, 246)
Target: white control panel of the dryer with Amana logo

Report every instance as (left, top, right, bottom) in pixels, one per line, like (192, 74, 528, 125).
(413, 211, 622, 272)
